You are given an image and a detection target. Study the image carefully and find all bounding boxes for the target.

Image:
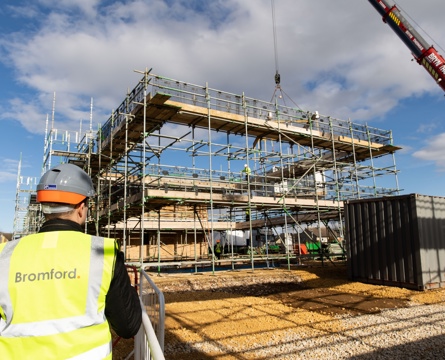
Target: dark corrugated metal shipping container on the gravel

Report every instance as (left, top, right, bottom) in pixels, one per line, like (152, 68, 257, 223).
(345, 194, 445, 290)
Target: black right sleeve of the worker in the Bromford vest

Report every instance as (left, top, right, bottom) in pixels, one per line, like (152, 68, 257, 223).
(105, 251, 142, 339)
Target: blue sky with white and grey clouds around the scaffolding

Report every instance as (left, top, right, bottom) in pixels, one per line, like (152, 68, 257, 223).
(0, 0, 445, 232)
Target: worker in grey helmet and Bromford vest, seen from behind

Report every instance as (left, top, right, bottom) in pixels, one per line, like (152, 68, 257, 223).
(0, 164, 142, 360)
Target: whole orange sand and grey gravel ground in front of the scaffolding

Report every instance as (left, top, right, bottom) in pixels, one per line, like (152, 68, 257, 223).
(111, 265, 445, 360)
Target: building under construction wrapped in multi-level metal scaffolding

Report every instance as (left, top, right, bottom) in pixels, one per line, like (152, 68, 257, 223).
(14, 71, 400, 266)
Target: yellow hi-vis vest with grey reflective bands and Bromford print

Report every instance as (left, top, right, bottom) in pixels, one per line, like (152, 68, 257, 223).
(0, 231, 117, 360)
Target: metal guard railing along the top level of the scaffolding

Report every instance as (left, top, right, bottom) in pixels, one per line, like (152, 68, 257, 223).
(100, 74, 393, 153)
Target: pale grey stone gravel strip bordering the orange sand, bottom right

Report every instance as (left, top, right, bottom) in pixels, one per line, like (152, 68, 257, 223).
(208, 305, 445, 359)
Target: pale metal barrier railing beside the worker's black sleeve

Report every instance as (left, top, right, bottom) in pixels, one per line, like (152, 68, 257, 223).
(134, 269, 165, 360)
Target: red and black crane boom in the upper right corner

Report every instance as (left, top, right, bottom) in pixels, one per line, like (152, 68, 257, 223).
(368, 0, 445, 91)
